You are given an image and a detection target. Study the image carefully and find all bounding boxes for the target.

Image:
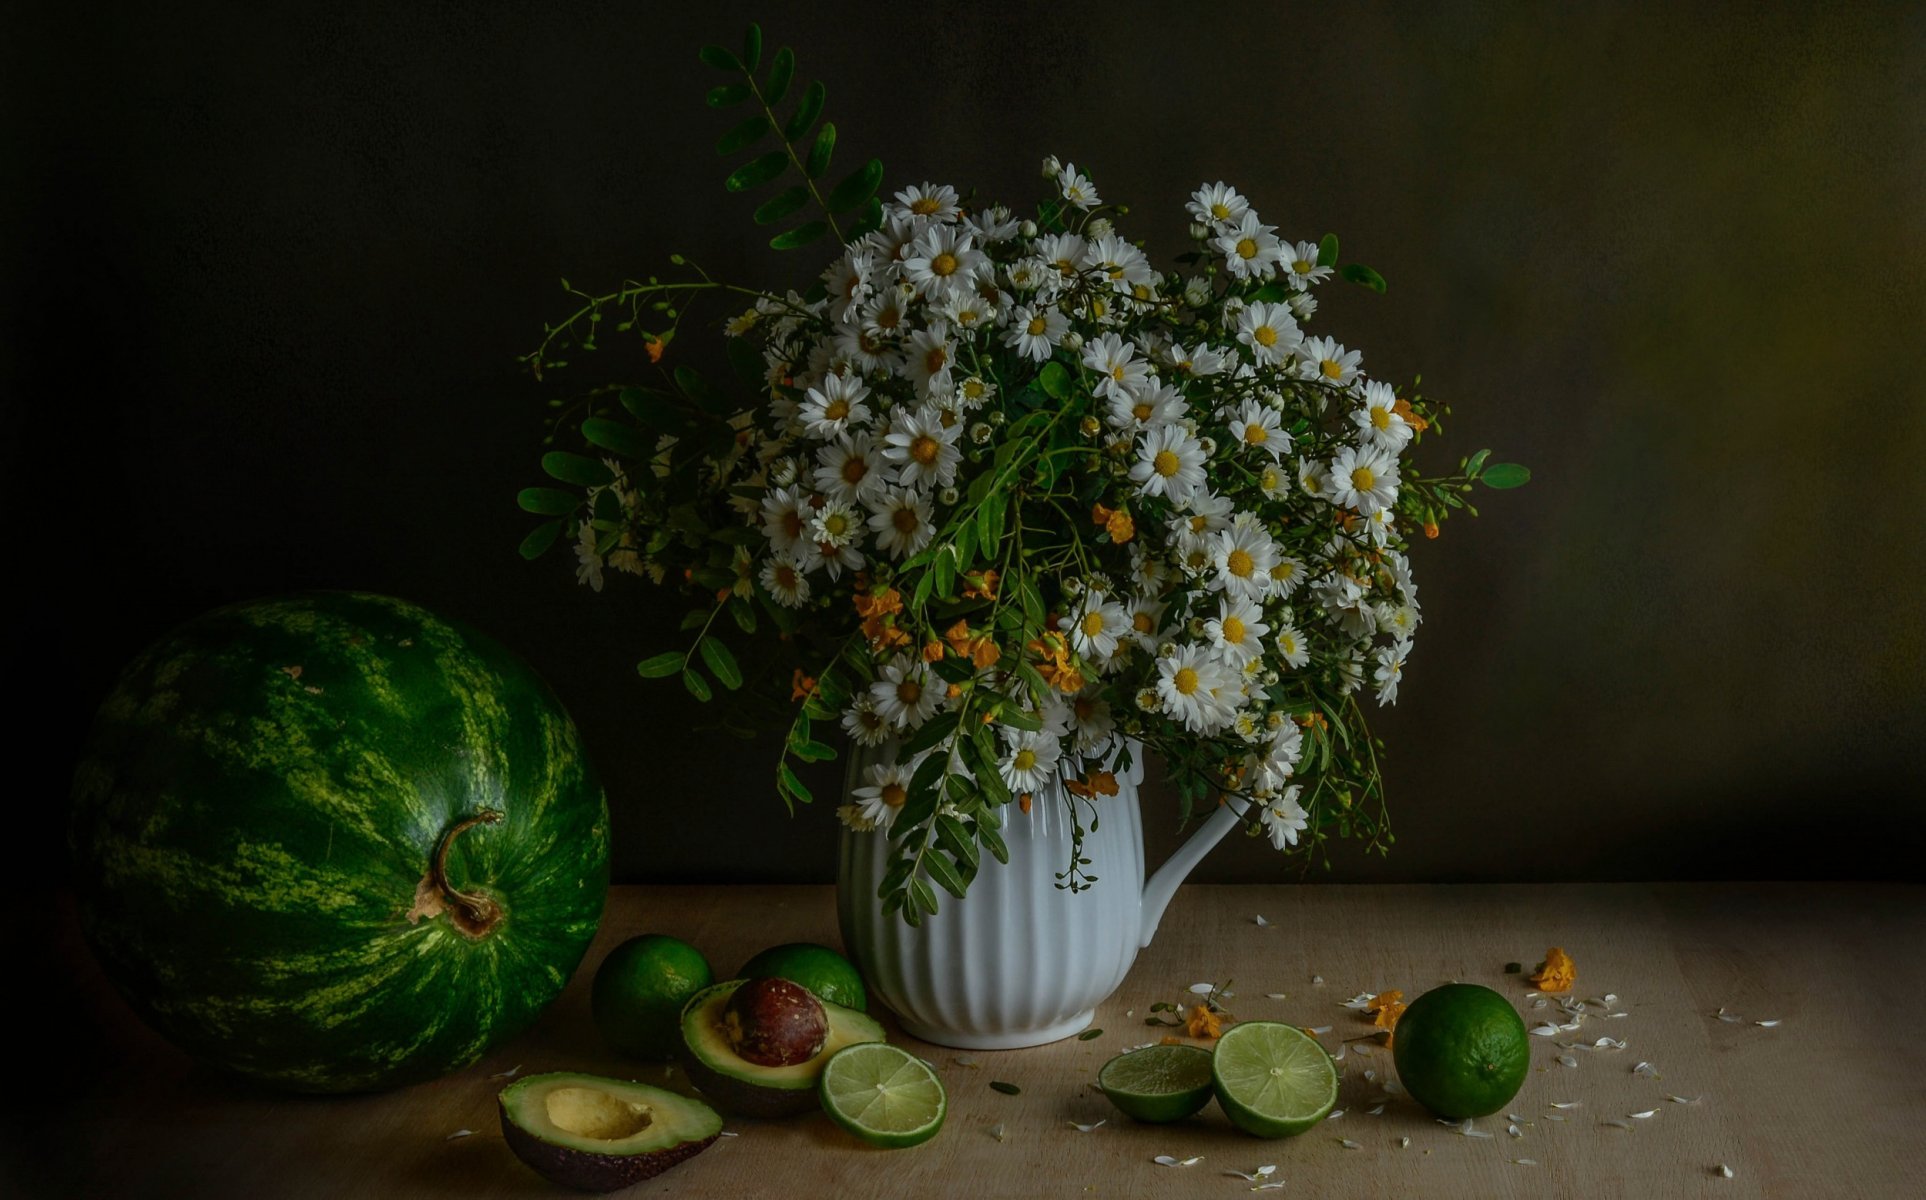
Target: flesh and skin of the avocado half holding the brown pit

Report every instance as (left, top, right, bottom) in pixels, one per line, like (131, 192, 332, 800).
(682, 978, 888, 1117)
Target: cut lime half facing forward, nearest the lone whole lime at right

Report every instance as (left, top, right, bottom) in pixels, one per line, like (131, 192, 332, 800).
(1211, 1021, 1337, 1138)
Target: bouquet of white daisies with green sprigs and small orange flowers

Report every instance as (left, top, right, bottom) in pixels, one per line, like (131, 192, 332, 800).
(522, 23, 1529, 921)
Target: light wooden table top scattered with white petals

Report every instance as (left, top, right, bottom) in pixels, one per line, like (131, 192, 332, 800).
(18, 884, 1926, 1200)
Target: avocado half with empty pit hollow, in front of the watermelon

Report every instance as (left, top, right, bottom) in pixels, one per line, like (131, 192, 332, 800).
(501, 1071, 722, 1192)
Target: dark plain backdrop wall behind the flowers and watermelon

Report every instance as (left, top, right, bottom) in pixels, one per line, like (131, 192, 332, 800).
(0, 2, 1926, 893)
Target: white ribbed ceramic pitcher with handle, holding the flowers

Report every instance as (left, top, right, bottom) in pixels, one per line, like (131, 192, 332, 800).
(836, 742, 1242, 1050)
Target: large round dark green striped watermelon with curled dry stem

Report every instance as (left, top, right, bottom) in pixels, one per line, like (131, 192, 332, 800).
(71, 593, 609, 1092)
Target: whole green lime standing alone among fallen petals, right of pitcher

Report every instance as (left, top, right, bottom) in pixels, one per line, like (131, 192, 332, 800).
(1391, 984, 1531, 1119)
